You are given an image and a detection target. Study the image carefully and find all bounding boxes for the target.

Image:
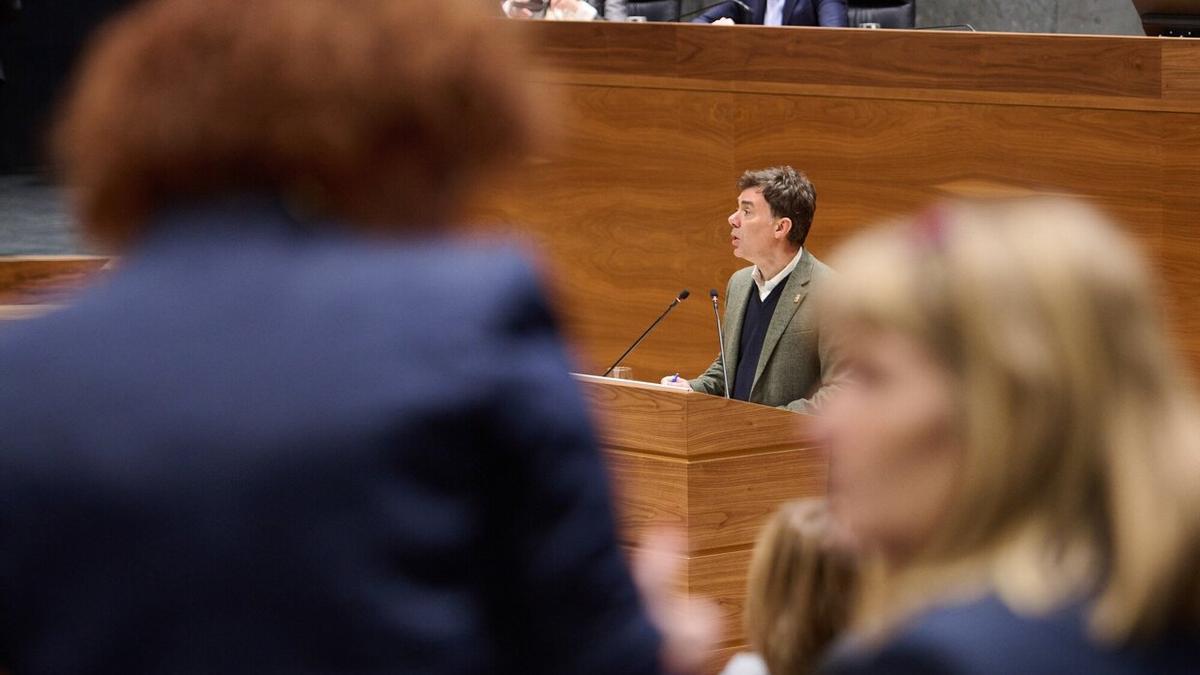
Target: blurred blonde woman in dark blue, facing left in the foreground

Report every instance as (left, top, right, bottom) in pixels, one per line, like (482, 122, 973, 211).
(818, 198, 1200, 674)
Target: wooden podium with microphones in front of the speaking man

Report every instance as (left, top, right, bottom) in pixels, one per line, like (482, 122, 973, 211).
(576, 375, 828, 663)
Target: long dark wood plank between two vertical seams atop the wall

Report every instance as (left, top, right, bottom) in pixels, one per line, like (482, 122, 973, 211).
(676, 26, 1160, 97)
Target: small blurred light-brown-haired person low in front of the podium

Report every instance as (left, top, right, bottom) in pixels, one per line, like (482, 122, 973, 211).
(721, 500, 858, 675)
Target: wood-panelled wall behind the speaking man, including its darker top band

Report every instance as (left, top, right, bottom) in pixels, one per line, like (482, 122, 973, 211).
(475, 23, 1200, 380)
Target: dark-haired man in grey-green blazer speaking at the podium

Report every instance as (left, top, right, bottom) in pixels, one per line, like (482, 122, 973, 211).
(662, 166, 839, 413)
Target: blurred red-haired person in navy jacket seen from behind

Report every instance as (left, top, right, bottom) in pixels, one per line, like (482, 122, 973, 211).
(0, 0, 706, 675)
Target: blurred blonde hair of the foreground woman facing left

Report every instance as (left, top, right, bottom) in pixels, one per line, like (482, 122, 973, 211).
(828, 198, 1200, 643)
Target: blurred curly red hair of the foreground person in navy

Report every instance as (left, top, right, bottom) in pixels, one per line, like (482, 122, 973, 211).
(54, 0, 535, 246)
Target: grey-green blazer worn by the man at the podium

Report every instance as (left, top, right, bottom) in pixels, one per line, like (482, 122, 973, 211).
(691, 250, 844, 413)
